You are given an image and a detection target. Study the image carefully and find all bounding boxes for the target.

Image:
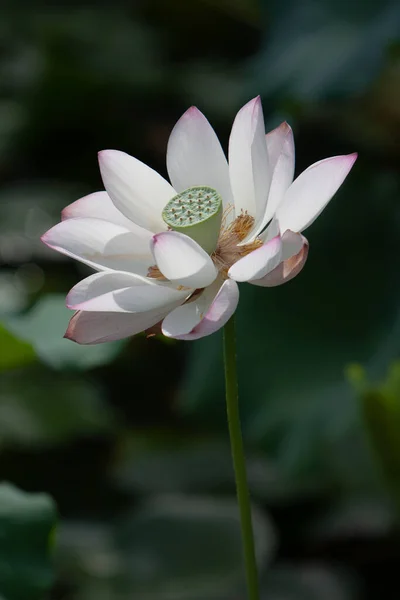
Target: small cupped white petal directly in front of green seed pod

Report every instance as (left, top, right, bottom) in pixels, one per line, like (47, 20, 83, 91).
(151, 231, 218, 288)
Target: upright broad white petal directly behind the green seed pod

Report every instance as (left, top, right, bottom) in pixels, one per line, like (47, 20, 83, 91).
(167, 106, 233, 216)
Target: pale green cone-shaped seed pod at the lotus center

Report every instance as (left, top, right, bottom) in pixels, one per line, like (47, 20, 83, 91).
(162, 186, 222, 254)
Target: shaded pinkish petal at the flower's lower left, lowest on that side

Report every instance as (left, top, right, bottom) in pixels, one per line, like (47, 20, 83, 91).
(64, 309, 175, 344)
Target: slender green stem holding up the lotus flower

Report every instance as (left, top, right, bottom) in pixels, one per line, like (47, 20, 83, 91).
(224, 317, 260, 600)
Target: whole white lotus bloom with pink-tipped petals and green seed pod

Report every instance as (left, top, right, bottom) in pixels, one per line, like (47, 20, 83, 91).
(42, 98, 357, 344)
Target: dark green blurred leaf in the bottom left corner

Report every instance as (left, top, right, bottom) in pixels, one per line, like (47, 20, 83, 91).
(0, 483, 56, 600)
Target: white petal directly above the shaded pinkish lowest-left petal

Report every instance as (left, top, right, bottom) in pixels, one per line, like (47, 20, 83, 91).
(67, 271, 190, 313)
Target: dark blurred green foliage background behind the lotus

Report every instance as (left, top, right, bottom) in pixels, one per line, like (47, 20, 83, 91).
(0, 0, 400, 600)
